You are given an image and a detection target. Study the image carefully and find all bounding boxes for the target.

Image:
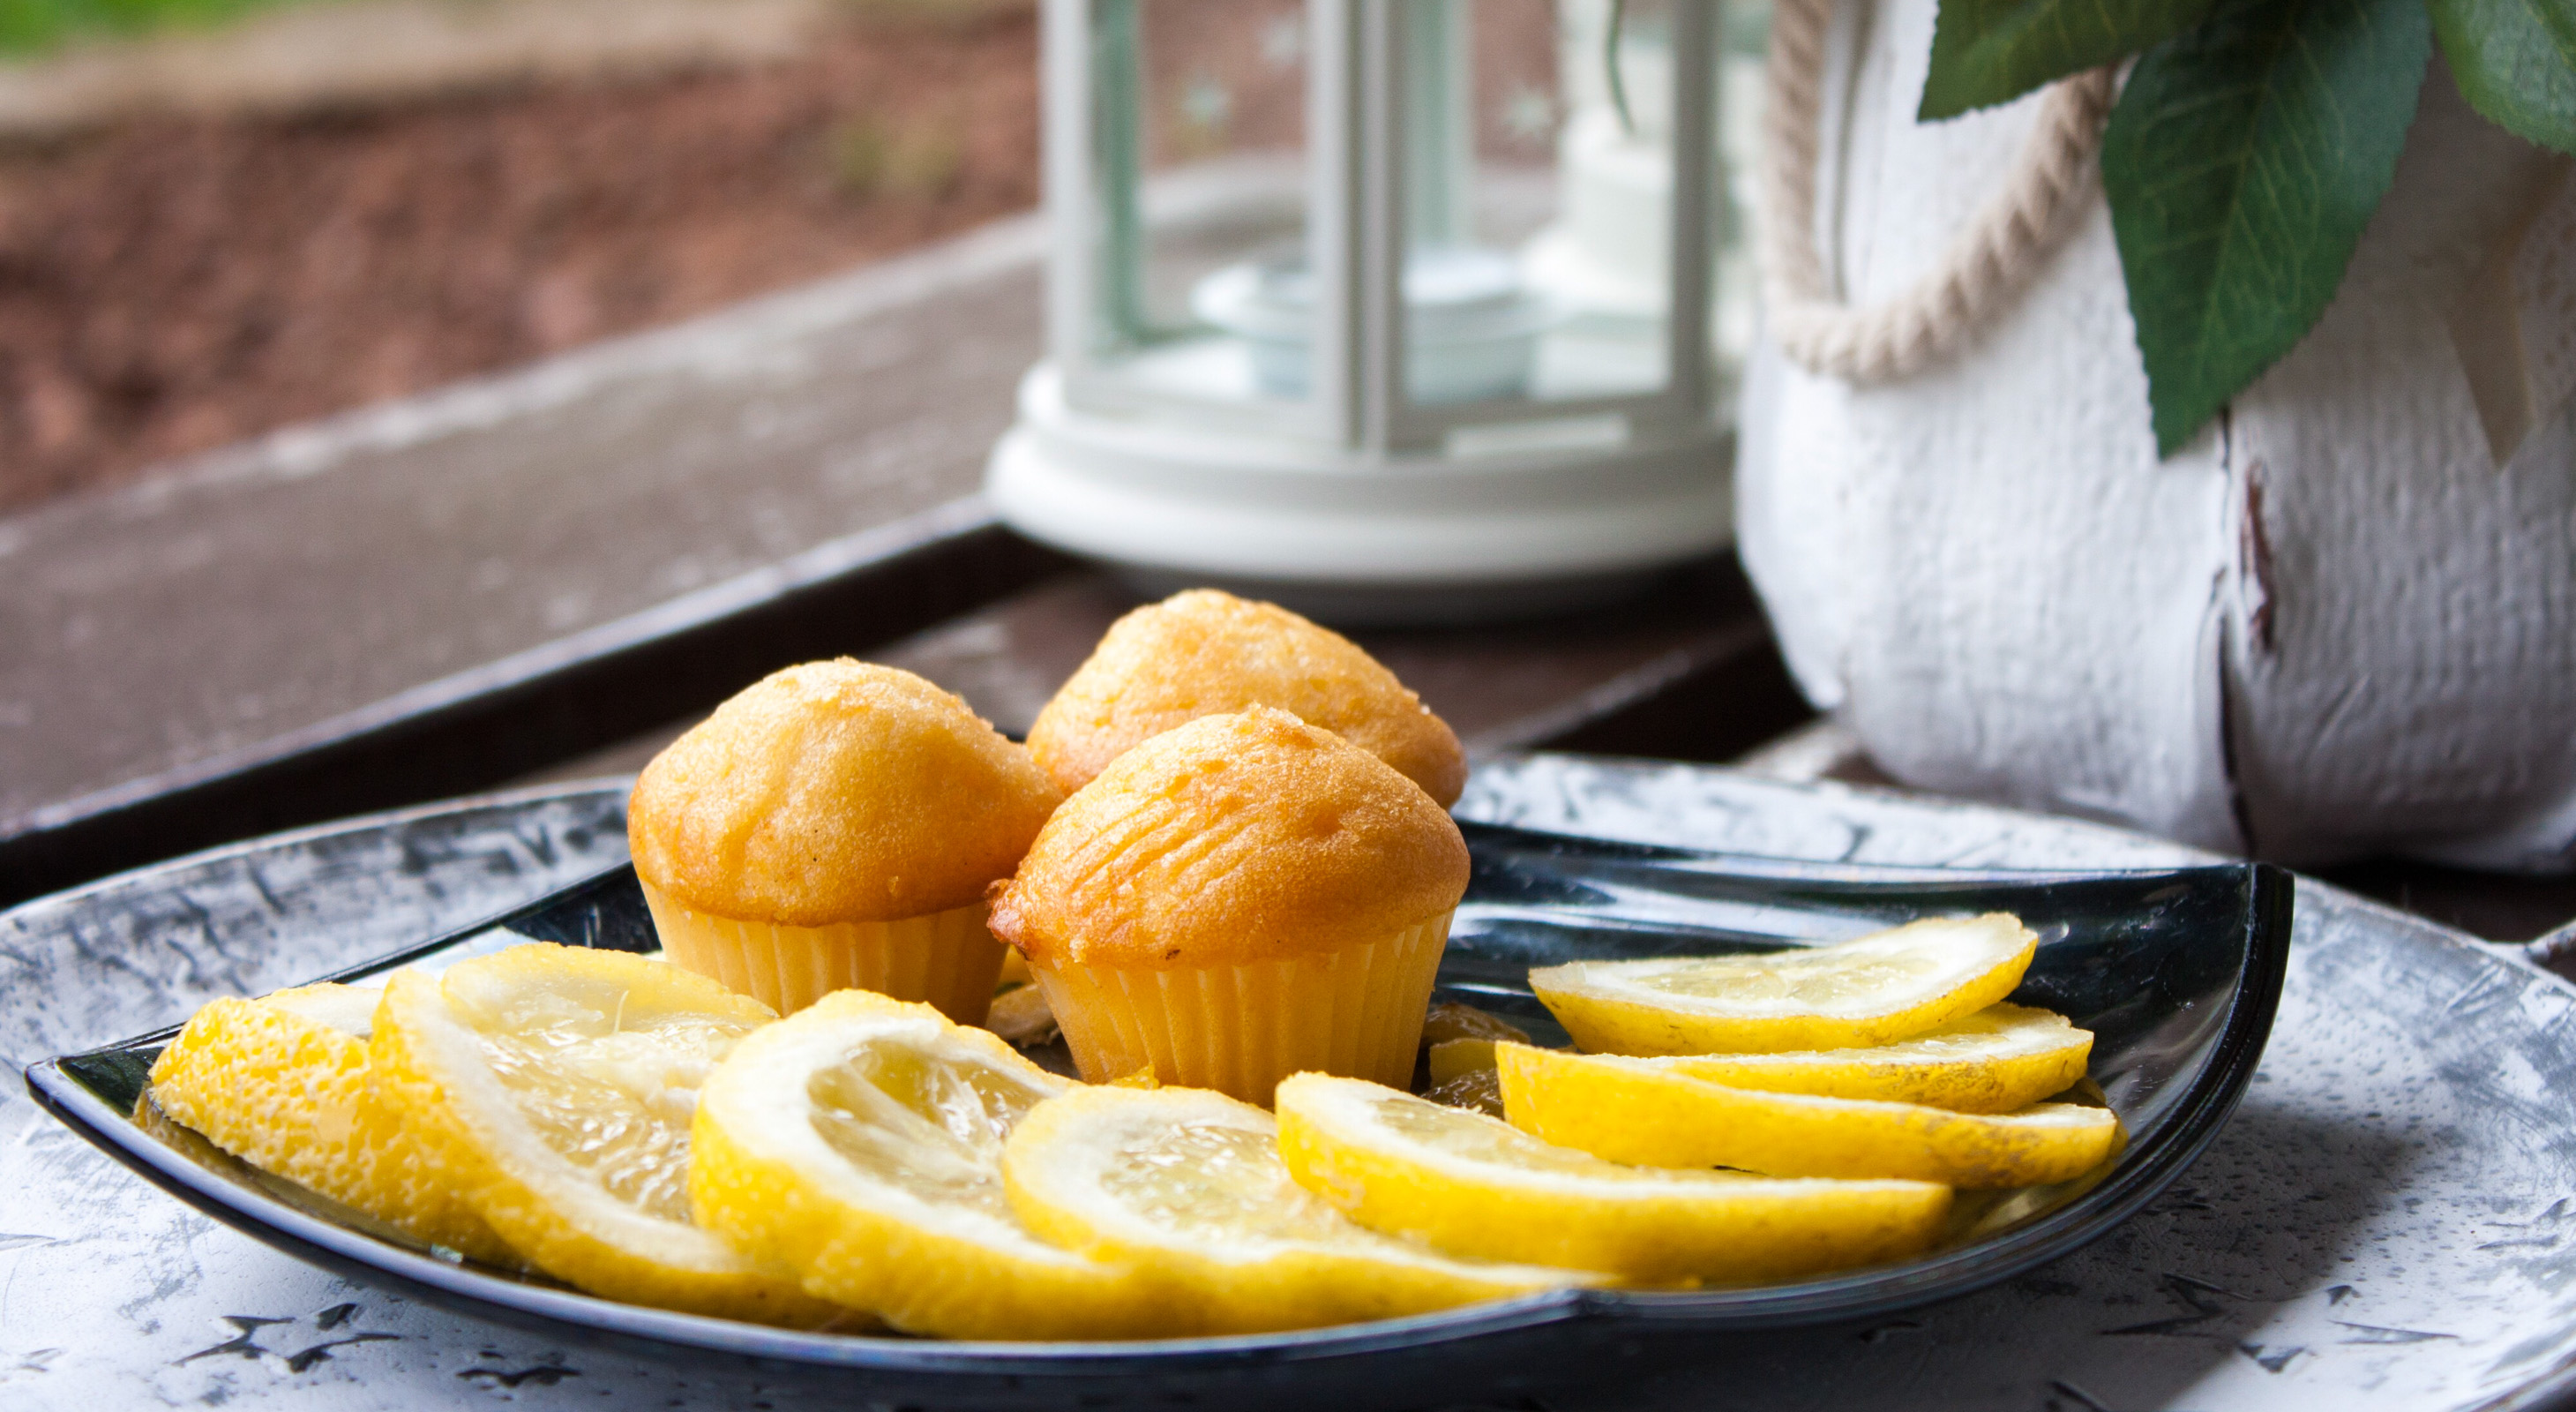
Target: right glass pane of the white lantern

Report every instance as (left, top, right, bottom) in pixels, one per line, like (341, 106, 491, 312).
(1397, 0, 1674, 407)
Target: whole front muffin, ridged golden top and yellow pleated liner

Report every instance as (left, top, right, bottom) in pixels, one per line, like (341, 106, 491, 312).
(992, 706, 1468, 1106)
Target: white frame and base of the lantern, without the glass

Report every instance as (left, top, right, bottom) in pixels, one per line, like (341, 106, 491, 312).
(986, 0, 1731, 621)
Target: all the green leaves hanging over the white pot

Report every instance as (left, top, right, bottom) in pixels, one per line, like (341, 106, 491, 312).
(1919, 0, 2576, 456)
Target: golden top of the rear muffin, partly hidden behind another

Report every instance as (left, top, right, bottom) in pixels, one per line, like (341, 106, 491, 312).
(1028, 588, 1465, 809)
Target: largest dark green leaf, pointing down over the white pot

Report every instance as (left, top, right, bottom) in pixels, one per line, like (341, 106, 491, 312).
(2102, 0, 2431, 456)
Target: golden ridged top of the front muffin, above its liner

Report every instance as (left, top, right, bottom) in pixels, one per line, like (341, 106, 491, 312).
(992, 706, 1465, 972)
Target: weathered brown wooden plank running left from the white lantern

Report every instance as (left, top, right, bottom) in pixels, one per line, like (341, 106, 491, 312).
(0, 216, 1044, 835)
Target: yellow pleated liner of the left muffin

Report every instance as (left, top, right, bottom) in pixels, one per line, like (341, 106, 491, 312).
(644, 883, 1007, 1025)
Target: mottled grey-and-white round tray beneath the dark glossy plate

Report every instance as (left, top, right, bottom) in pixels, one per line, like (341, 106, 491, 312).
(0, 755, 2576, 1412)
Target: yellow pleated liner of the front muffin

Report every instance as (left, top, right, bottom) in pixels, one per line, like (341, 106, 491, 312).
(1030, 913, 1450, 1108)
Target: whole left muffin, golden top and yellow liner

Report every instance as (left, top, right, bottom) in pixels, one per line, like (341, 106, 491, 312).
(626, 657, 1061, 1025)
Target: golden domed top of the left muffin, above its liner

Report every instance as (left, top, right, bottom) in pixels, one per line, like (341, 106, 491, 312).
(626, 657, 1061, 928)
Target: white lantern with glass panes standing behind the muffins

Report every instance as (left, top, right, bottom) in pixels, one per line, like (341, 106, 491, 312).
(989, 0, 1747, 621)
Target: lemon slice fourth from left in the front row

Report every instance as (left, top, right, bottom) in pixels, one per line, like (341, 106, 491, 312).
(1002, 1087, 1597, 1332)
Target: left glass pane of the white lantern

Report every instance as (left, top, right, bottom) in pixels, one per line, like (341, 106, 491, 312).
(1090, 0, 1314, 404)
